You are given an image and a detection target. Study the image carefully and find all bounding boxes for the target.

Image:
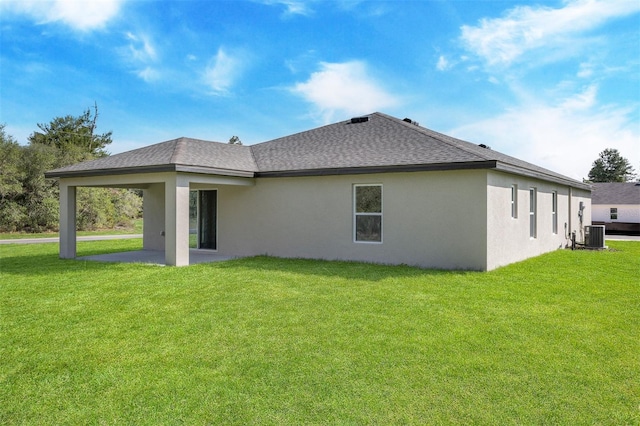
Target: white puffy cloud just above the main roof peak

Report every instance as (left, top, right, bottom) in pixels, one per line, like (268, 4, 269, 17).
(291, 61, 399, 122)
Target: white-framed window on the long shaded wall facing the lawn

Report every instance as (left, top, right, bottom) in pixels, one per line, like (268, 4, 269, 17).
(353, 185, 382, 243)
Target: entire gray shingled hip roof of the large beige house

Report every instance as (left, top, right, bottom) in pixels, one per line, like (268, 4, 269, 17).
(47, 113, 589, 189)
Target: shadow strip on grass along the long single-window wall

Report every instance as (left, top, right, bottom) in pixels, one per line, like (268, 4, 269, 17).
(208, 256, 472, 281)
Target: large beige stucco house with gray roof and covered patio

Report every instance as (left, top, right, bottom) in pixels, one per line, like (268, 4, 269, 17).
(46, 113, 590, 270)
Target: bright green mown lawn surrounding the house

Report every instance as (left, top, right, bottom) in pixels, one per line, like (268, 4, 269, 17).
(0, 240, 640, 425)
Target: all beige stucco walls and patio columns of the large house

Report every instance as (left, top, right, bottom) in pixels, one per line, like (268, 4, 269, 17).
(60, 170, 591, 270)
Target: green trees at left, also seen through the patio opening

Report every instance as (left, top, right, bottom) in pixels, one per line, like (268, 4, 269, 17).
(0, 105, 142, 232)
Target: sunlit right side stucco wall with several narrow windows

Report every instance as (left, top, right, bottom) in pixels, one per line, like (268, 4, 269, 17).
(487, 171, 591, 270)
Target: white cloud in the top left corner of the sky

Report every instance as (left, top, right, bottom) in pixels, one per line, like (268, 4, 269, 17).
(0, 0, 123, 31)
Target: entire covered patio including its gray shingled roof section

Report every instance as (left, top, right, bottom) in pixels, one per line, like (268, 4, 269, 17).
(45, 138, 256, 266)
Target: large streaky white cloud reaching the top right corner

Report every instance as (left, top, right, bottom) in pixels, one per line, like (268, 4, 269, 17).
(461, 0, 640, 65)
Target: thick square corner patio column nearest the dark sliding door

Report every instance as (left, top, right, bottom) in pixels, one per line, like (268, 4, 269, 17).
(165, 174, 189, 266)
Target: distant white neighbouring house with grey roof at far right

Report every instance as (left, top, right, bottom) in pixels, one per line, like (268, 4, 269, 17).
(591, 182, 640, 234)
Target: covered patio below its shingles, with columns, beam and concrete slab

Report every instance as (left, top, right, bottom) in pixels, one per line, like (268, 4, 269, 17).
(55, 172, 254, 266)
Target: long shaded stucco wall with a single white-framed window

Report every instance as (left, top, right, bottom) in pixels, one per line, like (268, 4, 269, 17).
(218, 171, 487, 270)
